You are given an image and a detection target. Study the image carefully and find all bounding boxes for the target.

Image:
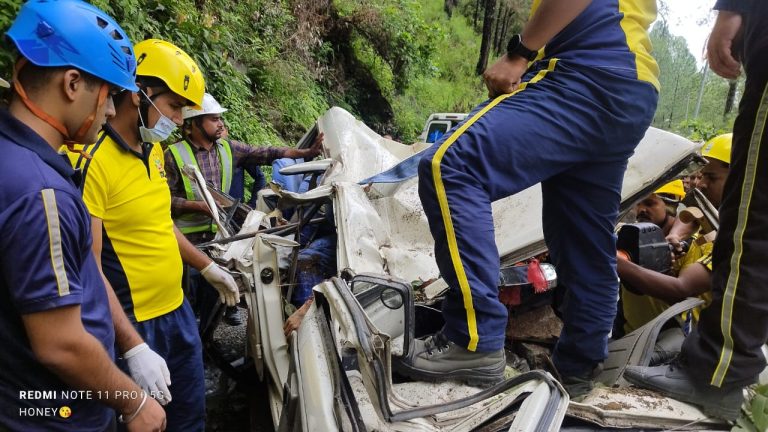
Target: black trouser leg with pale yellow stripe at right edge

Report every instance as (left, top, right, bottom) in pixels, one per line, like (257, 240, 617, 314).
(683, 47, 768, 387)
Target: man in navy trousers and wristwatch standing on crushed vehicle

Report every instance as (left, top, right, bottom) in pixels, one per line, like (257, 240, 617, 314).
(395, 0, 659, 396)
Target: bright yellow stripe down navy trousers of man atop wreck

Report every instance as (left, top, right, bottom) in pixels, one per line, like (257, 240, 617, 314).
(432, 58, 557, 351)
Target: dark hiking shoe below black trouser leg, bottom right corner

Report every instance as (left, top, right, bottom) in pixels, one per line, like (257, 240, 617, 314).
(624, 360, 744, 421)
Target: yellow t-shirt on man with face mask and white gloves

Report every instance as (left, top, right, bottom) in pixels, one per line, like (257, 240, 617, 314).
(70, 126, 184, 322)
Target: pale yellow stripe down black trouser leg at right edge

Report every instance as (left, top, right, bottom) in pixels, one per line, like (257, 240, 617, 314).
(710, 79, 768, 387)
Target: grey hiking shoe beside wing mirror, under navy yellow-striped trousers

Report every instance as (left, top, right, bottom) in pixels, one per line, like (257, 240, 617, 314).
(392, 332, 507, 387)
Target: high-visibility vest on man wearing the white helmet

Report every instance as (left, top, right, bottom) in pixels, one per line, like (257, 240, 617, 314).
(168, 139, 233, 234)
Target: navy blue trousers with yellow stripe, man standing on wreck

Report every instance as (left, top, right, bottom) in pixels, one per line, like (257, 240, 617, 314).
(419, 59, 658, 375)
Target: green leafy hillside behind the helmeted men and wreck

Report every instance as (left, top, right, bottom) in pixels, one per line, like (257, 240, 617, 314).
(0, 0, 510, 145)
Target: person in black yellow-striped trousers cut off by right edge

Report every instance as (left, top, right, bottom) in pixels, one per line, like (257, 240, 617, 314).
(624, 0, 768, 420)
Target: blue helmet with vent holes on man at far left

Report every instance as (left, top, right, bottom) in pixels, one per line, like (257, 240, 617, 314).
(6, 0, 138, 91)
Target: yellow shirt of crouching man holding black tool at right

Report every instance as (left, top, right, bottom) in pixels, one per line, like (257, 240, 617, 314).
(621, 242, 713, 333)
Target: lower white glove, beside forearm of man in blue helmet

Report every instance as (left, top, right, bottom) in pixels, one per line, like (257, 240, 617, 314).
(123, 343, 171, 405)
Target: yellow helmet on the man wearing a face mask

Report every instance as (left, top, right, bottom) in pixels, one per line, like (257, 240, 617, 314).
(133, 39, 205, 109)
